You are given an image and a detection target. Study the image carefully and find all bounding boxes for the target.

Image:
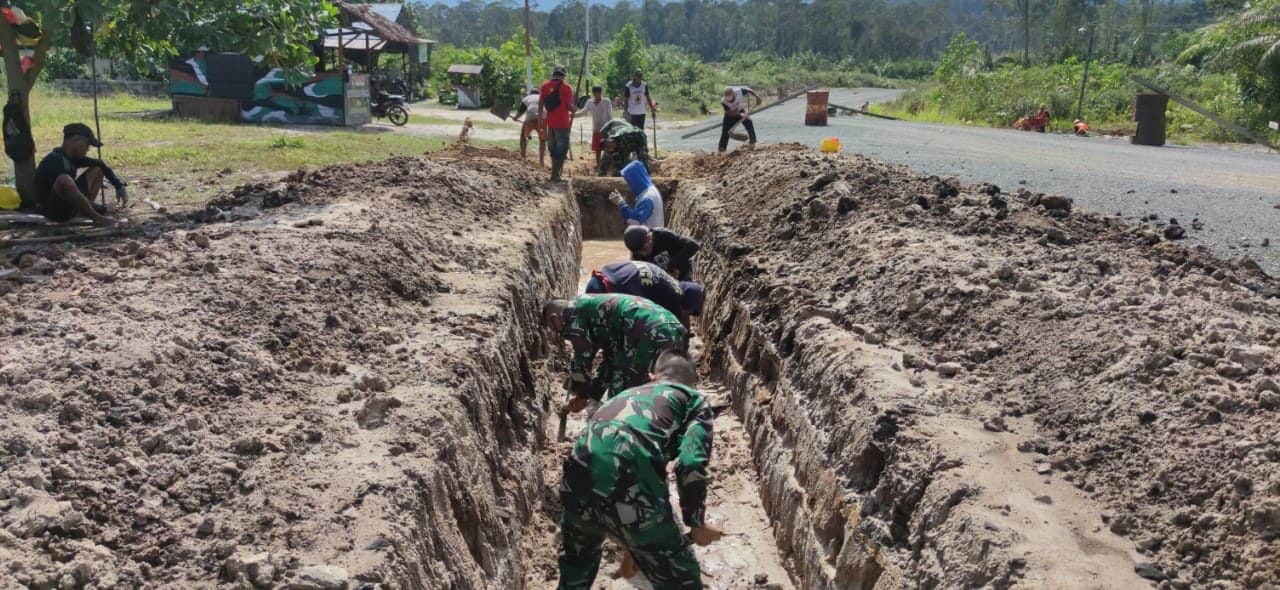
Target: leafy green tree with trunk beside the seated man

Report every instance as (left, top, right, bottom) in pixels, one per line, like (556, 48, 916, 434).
(0, 0, 335, 200)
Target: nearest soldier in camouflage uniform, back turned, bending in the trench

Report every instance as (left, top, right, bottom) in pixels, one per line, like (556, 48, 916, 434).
(559, 352, 721, 590)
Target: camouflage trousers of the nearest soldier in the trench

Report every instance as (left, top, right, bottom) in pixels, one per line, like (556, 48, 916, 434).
(559, 457, 703, 590)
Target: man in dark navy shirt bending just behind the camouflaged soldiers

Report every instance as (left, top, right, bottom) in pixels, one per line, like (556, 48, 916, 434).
(586, 260, 705, 328)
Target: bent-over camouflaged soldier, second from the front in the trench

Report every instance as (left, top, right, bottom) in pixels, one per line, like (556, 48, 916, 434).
(543, 294, 689, 401)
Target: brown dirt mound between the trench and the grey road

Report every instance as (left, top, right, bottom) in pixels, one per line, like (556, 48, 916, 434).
(677, 147, 1280, 587)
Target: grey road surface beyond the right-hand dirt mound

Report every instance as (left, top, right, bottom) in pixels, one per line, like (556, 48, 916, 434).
(658, 88, 1280, 276)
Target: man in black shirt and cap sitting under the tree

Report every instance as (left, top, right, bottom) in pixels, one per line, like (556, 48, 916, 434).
(36, 123, 128, 225)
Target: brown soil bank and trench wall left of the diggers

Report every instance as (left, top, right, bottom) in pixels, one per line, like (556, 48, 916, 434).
(0, 152, 579, 589)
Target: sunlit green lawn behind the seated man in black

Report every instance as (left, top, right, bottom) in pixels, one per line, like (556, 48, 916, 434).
(16, 87, 515, 202)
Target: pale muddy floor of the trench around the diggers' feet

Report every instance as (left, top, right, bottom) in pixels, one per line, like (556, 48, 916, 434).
(531, 241, 794, 590)
